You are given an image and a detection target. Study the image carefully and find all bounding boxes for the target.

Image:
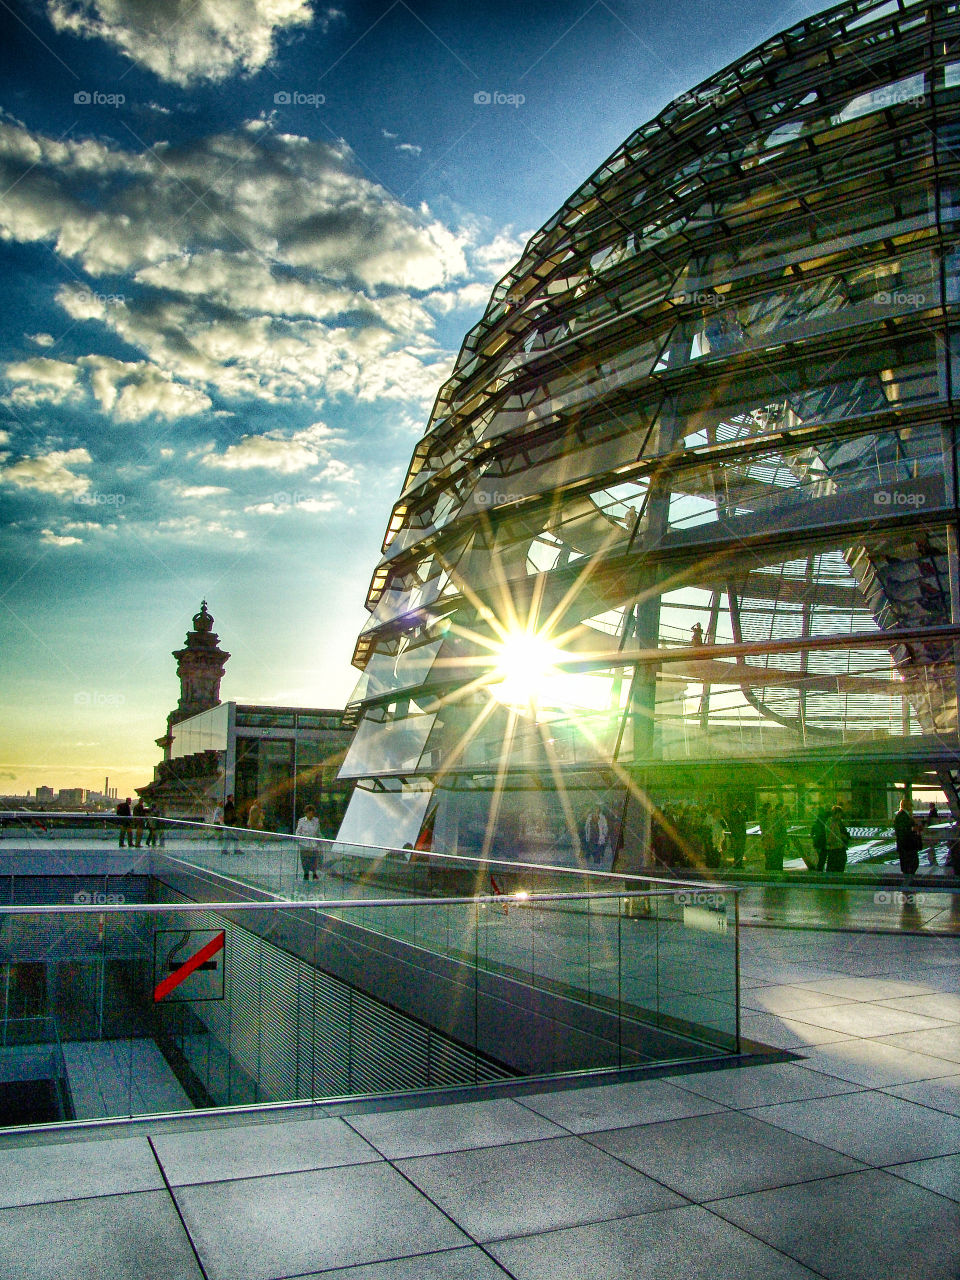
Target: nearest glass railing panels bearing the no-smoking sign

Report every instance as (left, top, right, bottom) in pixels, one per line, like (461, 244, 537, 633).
(0, 850, 739, 1125)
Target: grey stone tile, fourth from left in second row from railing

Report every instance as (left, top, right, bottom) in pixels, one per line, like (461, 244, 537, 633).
(589, 1100, 860, 1201)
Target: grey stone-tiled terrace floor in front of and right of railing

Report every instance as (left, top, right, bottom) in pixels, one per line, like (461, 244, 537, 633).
(0, 929, 960, 1280)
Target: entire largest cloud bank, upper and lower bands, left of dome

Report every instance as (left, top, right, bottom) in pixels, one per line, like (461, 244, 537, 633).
(0, 114, 518, 421)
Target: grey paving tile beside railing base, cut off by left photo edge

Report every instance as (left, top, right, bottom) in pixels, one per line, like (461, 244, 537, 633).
(0, 1138, 164, 1207)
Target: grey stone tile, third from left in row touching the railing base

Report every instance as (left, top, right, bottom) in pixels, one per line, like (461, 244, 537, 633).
(349, 1098, 563, 1160)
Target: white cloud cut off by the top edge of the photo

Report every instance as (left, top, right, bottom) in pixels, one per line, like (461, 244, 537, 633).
(46, 0, 327, 86)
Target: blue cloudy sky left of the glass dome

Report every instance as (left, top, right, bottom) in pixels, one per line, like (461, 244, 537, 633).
(0, 0, 819, 792)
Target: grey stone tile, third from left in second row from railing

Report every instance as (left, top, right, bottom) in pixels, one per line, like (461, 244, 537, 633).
(398, 1137, 685, 1240)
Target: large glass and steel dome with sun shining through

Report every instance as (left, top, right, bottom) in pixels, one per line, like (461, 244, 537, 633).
(340, 0, 960, 867)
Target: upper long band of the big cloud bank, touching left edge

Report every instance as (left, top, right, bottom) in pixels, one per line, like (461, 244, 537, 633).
(0, 120, 466, 289)
